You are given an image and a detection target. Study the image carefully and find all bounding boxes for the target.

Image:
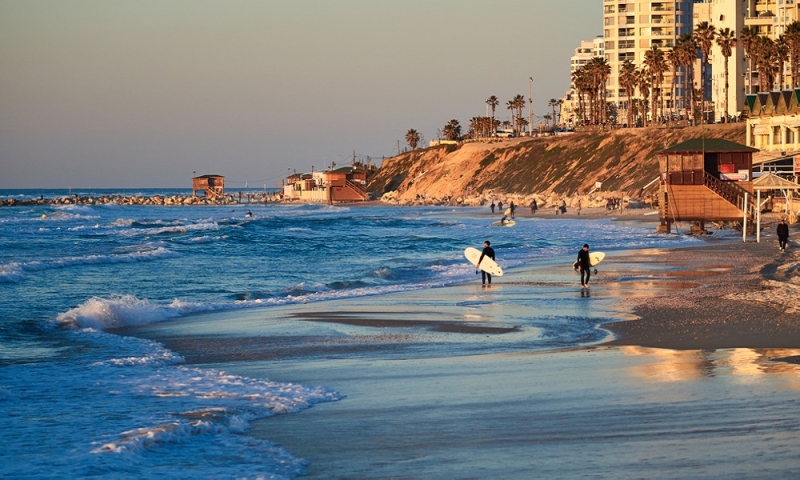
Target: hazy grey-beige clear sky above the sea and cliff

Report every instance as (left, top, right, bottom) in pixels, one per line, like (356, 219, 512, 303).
(0, 0, 602, 190)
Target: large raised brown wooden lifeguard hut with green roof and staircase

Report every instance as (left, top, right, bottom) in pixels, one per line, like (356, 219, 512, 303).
(657, 138, 758, 233)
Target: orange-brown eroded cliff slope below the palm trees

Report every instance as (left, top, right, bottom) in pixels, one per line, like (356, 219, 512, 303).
(367, 123, 745, 203)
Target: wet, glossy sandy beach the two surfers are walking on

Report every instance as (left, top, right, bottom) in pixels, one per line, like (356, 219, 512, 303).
(119, 209, 800, 478)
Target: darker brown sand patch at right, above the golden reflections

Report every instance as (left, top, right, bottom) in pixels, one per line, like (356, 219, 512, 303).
(603, 237, 800, 350)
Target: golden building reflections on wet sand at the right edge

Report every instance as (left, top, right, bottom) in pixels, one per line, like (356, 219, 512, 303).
(618, 346, 800, 389)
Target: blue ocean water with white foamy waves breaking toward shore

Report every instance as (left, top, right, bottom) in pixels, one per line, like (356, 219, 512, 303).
(0, 190, 700, 478)
